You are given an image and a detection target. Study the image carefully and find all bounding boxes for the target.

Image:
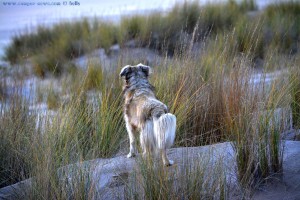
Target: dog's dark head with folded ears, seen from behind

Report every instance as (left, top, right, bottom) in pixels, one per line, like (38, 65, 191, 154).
(120, 63, 151, 83)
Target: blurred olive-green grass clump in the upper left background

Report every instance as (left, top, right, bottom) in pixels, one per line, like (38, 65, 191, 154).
(5, 19, 118, 77)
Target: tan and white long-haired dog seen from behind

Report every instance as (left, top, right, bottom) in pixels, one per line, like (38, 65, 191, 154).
(120, 64, 176, 166)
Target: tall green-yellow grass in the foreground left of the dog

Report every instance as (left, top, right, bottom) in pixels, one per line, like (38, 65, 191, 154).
(0, 69, 126, 195)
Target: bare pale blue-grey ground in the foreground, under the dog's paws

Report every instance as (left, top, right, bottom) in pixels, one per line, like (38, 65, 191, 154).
(0, 141, 300, 200)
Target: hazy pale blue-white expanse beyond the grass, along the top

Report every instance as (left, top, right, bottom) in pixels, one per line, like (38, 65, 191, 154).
(0, 0, 285, 60)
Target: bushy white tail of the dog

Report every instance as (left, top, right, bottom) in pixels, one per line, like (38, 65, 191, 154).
(153, 113, 176, 149)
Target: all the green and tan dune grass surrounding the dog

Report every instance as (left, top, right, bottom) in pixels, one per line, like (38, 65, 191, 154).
(0, 1, 300, 199)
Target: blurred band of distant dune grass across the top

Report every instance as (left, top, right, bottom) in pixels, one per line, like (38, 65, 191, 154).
(4, 0, 300, 77)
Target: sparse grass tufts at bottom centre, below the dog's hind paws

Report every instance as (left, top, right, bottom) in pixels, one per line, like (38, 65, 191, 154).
(124, 152, 229, 199)
